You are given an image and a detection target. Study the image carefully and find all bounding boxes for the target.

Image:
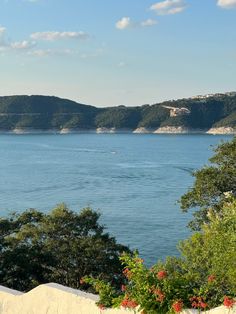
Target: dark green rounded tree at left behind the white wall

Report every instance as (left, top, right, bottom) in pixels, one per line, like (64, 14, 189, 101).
(0, 204, 129, 291)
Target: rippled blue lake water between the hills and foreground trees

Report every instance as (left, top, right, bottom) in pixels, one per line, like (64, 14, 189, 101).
(0, 134, 231, 265)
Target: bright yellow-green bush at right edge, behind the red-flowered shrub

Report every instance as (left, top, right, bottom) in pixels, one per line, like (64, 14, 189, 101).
(179, 196, 236, 302)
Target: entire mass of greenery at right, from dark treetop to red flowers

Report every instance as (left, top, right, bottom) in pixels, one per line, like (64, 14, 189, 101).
(84, 138, 236, 314)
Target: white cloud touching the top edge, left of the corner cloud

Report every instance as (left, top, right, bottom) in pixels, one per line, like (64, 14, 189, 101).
(150, 0, 186, 15)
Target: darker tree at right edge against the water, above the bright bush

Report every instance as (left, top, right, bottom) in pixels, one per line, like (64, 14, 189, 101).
(180, 137, 236, 230)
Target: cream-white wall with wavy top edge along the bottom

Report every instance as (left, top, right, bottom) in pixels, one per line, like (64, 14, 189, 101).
(0, 283, 236, 314)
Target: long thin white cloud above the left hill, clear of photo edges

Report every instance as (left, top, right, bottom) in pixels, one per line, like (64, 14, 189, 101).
(30, 32, 89, 41)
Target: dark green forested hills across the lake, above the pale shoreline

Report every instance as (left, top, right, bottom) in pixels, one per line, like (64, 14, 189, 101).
(0, 92, 236, 130)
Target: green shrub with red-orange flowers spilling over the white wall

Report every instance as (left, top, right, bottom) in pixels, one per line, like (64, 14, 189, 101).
(83, 253, 235, 314)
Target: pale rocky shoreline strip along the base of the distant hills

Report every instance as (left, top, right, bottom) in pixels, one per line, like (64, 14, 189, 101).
(0, 126, 236, 135)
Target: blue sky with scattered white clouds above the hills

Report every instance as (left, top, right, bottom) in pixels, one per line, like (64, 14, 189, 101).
(0, 0, 236, 107)
